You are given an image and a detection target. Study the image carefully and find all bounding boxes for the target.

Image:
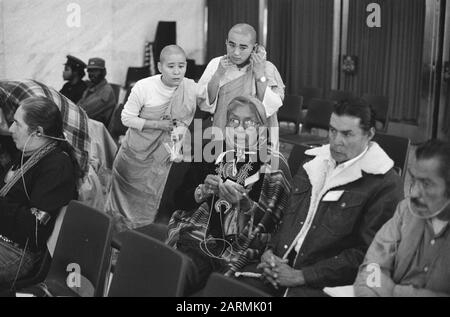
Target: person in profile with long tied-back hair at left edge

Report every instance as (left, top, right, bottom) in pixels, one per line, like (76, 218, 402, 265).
(0, 97, 82, 289)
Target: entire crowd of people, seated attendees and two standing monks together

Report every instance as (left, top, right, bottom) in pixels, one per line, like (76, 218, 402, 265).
(0, 23, 450, 297)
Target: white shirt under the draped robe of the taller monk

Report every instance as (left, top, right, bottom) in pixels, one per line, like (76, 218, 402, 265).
(198, 56, 284, 117)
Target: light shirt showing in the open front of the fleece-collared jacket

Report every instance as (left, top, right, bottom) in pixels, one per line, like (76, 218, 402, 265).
(292, 146, 369, 256)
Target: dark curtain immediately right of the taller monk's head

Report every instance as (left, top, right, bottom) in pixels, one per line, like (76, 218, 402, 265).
(267, 0, 333, 94)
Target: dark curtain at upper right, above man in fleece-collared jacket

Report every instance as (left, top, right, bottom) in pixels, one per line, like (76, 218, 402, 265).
(341, 0, 425, 124)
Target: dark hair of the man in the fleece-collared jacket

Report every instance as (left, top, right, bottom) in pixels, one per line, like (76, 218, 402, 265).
(333, 100, 375, 132)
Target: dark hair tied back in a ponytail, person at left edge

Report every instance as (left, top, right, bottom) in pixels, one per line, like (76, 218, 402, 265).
(20, 97, 84, 179)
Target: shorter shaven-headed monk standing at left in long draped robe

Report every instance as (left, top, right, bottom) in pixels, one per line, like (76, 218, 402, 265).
(106, 45, 206, 231)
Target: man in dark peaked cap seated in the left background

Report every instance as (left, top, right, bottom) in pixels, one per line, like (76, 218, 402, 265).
(59, 55, 87, 103)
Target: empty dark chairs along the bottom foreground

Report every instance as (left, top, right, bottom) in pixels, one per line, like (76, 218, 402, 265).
(7, 201, 267, 297)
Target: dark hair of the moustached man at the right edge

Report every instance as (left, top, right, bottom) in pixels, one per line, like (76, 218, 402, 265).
(416, 139, 450, 197)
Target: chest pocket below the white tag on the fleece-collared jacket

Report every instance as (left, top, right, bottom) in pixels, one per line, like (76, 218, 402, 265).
(321, 191, 367, 236)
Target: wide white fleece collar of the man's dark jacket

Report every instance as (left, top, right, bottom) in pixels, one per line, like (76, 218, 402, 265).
(303, 142, 394, 187)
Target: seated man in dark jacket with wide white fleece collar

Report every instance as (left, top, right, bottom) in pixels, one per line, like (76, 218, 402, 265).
(250, 102, 403, 296)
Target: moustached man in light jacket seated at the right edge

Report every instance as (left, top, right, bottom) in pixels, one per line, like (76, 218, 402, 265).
(355, 140, 450, 297)
